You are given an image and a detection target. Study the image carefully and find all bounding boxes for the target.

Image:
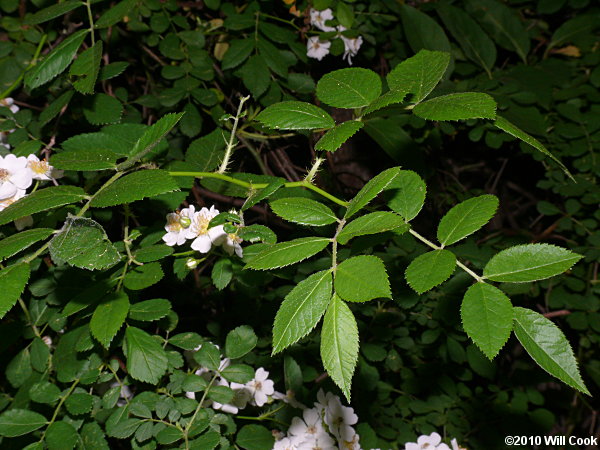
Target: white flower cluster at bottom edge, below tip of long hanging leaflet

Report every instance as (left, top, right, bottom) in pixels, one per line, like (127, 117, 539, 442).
(273, 390, 361, 450)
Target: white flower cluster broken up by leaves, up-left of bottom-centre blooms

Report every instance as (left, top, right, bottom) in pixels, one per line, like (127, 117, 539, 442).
(185, 350, 275, 414)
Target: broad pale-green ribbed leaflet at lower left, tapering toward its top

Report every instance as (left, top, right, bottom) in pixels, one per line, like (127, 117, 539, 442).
(125, 327, 167, 384)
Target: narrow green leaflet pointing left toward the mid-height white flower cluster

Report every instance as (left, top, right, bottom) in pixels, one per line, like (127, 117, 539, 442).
(244, 237, 331, 270)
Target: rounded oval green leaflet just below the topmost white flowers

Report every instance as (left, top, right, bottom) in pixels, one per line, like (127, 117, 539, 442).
(317, 67, 381, 108)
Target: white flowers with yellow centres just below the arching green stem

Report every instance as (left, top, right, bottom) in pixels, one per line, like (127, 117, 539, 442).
(163, 205, 243, 258)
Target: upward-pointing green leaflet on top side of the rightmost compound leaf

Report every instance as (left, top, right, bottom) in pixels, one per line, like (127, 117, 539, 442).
(437, 195, 498, 246)
